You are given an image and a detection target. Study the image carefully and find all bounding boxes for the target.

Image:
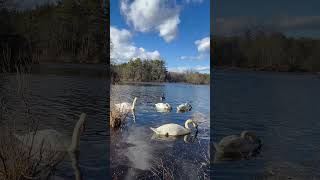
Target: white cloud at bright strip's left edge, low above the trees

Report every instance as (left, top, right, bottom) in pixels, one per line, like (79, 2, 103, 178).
(110, 26, 160, 63)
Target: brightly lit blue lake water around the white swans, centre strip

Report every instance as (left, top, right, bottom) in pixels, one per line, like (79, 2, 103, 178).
(110, 83, 210, 179)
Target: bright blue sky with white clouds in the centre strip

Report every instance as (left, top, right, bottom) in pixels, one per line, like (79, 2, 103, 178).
(110, 0, 210, 73)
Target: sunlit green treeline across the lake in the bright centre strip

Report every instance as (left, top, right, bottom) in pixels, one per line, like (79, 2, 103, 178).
(111, 58, 210, 84)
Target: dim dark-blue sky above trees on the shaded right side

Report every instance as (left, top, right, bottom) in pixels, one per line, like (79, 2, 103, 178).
(213, 0, 320, 37)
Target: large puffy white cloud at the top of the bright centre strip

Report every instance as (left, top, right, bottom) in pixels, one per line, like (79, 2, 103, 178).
(120, 0, 180, 42)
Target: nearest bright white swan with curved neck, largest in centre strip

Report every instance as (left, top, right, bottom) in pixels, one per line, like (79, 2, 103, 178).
(150, 119, 198, 136)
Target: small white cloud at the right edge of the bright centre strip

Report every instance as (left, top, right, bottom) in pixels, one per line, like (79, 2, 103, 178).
(179, 37, 210, 60)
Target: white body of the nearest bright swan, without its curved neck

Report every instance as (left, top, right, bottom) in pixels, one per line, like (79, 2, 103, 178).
(154, 124, 190, 136)
